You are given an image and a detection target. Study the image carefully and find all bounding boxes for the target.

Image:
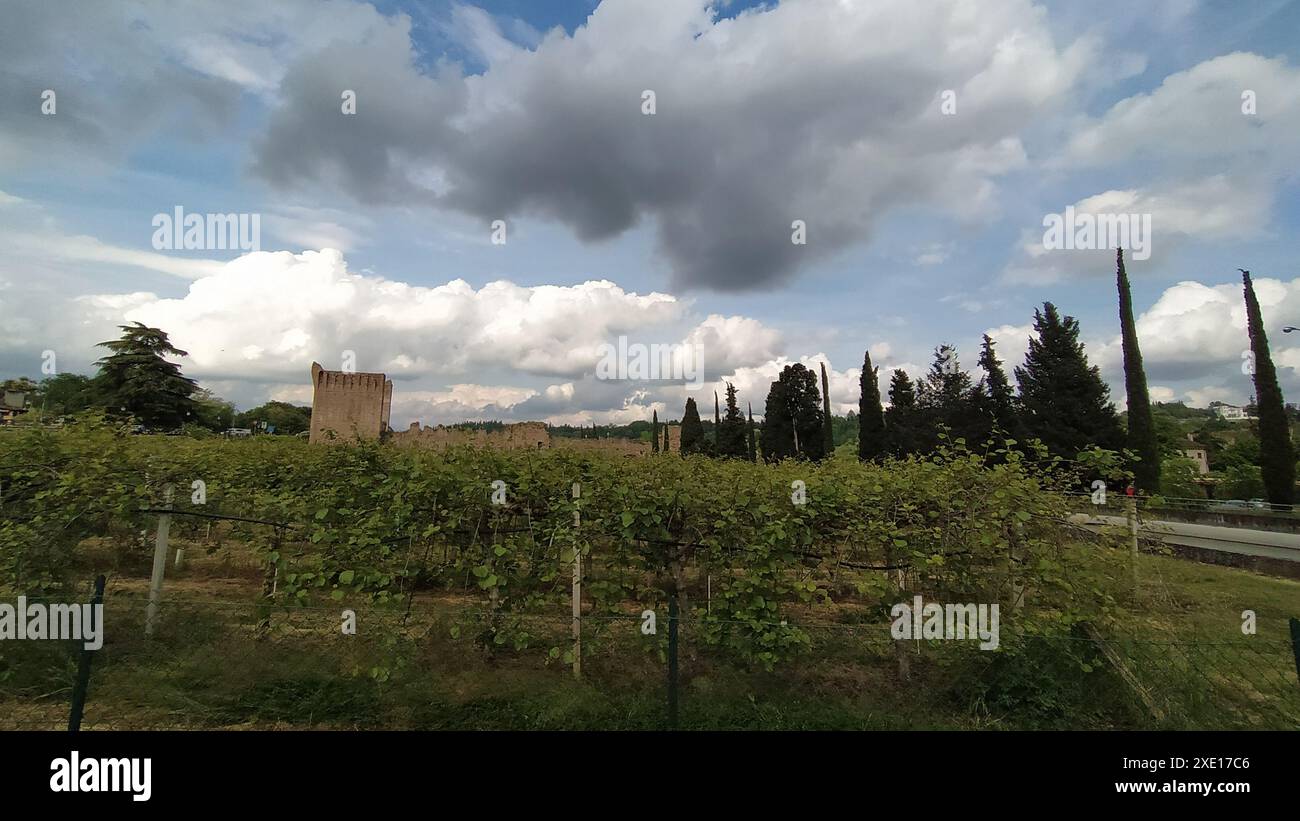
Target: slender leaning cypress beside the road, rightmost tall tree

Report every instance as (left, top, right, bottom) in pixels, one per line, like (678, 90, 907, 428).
(1238, 269, 1296, 504)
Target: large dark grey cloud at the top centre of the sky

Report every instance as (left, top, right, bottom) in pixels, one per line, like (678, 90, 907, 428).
(254, 0, 1087, 291)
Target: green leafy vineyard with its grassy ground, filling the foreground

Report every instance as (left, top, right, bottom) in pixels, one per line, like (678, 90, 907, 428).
(0, 422, 1300, 727)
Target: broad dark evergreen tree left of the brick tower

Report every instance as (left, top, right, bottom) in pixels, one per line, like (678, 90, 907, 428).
(94, 322, 199, 429)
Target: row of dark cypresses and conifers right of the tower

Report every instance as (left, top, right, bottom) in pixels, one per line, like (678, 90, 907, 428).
(651, 249, 1296, 504)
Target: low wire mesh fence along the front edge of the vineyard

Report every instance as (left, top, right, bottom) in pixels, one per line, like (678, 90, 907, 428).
(0, 590, 1300, 730)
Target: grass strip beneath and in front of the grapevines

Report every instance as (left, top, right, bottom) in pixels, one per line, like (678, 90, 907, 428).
(0, 549, 1300, 730)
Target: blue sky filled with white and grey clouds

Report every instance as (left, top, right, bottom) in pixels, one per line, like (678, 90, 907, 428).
(0, 0, 1300, 427)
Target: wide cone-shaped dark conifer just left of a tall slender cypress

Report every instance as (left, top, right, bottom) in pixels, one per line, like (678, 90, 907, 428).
(1015, 303, 1125, 459)
